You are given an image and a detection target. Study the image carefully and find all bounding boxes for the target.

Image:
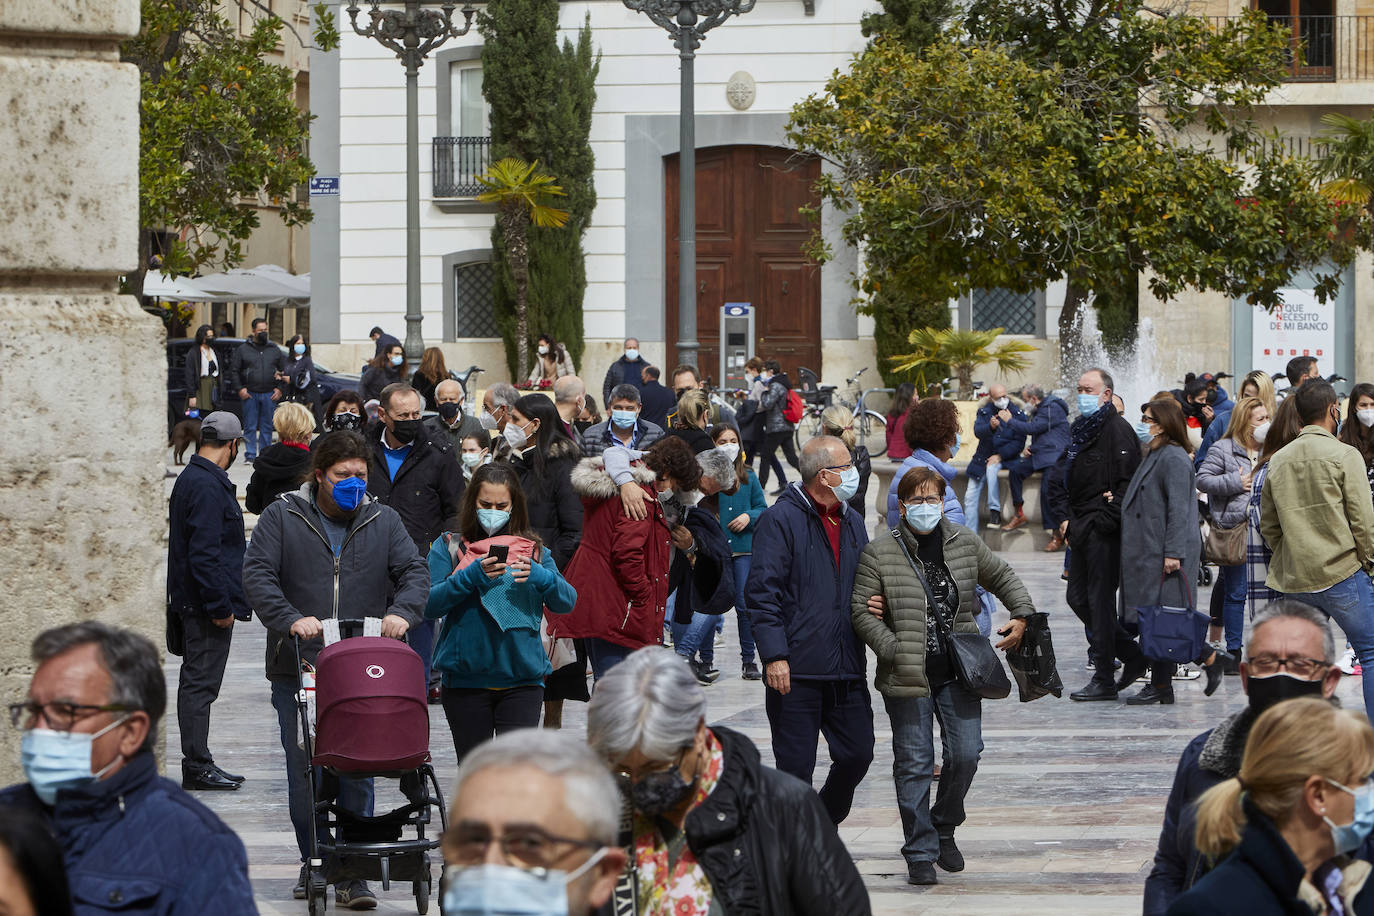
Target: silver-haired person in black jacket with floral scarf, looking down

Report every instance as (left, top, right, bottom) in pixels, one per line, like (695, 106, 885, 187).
(588, 645, 871, 916)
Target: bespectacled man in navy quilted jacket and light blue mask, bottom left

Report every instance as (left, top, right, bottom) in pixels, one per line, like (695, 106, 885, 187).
(0, 621, 257, 916)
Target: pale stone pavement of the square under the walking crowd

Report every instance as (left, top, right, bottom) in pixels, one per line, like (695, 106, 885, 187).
(160, 513, 1360, 916)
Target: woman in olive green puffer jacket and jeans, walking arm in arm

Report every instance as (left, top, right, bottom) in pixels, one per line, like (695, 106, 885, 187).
(851, 469, 1036, 884)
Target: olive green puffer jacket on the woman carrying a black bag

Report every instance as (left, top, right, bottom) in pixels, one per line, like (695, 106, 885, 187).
(849, 519, 1035, 696)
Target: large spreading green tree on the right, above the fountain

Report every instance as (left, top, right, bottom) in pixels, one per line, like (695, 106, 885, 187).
(789, 0, 1369, 365)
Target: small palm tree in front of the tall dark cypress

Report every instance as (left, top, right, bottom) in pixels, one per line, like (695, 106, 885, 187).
(477, 158, 569, 379)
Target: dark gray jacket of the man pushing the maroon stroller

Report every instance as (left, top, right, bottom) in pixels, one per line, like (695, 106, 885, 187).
(243, 483, 429, 680)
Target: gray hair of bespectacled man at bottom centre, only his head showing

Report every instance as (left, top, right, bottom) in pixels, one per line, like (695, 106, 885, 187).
(449, 728, 621, 846)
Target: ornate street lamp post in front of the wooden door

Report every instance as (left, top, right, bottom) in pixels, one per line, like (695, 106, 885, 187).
(624, 0, 756, 365)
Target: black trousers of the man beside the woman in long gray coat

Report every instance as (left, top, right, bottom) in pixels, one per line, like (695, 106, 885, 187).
(1065, 532, 1142, 685)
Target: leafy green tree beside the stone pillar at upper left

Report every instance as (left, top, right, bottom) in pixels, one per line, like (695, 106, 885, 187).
(121, 0, 338, 295)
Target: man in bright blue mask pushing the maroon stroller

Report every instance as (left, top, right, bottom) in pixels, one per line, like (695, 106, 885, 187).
(243, 430, 429, 909)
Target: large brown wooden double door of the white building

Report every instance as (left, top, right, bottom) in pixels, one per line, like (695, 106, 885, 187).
(664, 147, 822, 383)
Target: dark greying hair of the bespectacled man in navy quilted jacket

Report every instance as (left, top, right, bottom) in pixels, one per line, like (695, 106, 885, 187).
(29, 621, 168, 750)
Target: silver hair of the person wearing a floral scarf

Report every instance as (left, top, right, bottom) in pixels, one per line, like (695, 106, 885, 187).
(587, 645, 706, 761)
